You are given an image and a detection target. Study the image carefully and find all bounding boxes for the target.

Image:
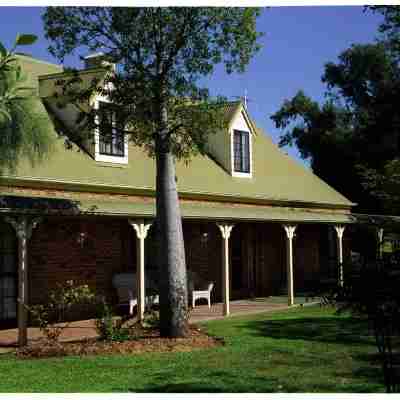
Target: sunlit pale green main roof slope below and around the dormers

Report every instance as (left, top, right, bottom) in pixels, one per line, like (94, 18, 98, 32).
(0, 57, 352, 209)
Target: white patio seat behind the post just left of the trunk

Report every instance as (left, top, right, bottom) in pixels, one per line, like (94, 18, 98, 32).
(112, 272, 159, 315)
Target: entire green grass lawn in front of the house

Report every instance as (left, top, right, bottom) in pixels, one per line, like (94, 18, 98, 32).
(0, 306, 384, 392)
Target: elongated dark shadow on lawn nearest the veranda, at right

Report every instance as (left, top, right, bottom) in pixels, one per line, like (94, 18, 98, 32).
(242, 317, 375, 345)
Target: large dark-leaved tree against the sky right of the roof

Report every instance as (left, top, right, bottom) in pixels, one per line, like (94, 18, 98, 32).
(272, 8, 400, 212)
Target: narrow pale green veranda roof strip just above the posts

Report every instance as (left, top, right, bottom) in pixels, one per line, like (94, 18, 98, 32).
(0, 195, 353, 224)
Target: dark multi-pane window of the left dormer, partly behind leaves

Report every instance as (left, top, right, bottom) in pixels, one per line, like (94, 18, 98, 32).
(99, 102, 125, 157)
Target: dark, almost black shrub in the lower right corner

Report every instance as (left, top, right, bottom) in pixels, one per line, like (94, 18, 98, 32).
(323, 260, 400, 393)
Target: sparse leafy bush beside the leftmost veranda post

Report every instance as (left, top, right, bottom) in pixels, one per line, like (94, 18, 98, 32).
(26, 280, 94, 342)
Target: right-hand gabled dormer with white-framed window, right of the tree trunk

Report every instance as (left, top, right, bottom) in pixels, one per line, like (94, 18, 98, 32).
(208, 101, 256, 178)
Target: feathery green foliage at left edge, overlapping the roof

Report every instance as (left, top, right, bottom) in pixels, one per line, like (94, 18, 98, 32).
(0, 35, 53, 171)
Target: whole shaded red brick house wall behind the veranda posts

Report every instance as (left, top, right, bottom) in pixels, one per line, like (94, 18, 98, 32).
(29, 218, 328, 303)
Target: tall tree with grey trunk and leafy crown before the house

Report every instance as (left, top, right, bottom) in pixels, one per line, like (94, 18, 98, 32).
(43, 7, 260, 336)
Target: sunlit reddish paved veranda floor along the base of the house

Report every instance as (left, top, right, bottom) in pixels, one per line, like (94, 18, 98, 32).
(0, 296, 314, 353)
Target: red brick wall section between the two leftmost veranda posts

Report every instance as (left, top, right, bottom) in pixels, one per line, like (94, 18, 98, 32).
(29, 218, 135, 303)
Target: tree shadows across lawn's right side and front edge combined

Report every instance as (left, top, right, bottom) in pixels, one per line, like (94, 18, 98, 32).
(116, 316, 384, 393)
